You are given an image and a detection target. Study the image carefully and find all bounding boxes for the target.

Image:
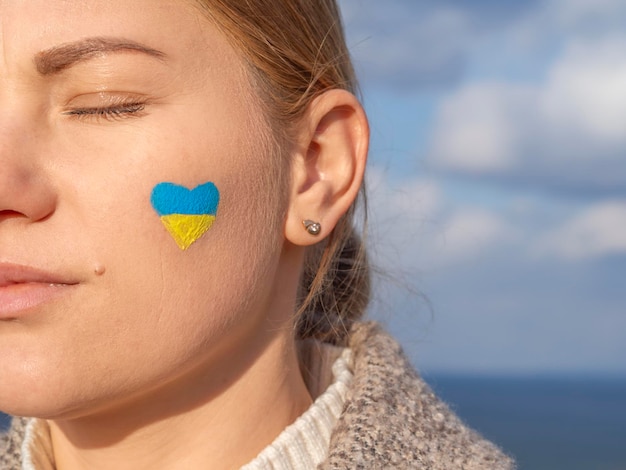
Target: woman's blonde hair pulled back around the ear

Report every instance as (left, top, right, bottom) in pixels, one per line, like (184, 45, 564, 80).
(196, 0, 370, 344)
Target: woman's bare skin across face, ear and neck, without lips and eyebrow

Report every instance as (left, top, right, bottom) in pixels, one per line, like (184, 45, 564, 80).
(0, 0, 367, 470)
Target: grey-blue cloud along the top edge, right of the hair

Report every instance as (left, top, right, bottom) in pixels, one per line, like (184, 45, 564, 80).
(339, 0, 626, 91)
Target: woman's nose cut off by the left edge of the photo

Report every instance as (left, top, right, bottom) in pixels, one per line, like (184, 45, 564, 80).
(0, 115, 56, 227)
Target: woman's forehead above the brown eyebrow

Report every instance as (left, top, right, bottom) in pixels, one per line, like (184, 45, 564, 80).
(0, 0, 234, 72)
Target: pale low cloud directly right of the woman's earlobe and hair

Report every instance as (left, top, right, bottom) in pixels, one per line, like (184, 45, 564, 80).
(368, 168, 519, 270)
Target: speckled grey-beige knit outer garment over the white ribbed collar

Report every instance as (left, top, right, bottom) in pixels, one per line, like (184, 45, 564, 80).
(0, 323, 515, 470)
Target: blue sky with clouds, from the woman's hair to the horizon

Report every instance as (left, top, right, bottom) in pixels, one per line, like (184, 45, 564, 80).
(339, 0, 626, 374)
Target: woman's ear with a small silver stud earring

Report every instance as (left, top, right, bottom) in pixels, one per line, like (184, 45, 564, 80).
(285, 90, 369, 246)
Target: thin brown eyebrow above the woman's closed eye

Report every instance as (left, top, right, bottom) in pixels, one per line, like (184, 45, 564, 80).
(34, 37, 165, 75)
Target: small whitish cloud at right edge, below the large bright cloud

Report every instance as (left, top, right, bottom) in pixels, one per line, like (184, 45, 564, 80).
(535, 201, 626, 260)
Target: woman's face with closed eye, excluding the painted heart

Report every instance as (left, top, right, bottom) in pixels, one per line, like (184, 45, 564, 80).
(0, 0, 290, 417)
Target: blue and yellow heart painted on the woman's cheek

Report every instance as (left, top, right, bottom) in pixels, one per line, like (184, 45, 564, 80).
(150, 182, 220, 250)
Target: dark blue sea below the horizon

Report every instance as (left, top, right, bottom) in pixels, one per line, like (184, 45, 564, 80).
(0, 374, 626, 470)
